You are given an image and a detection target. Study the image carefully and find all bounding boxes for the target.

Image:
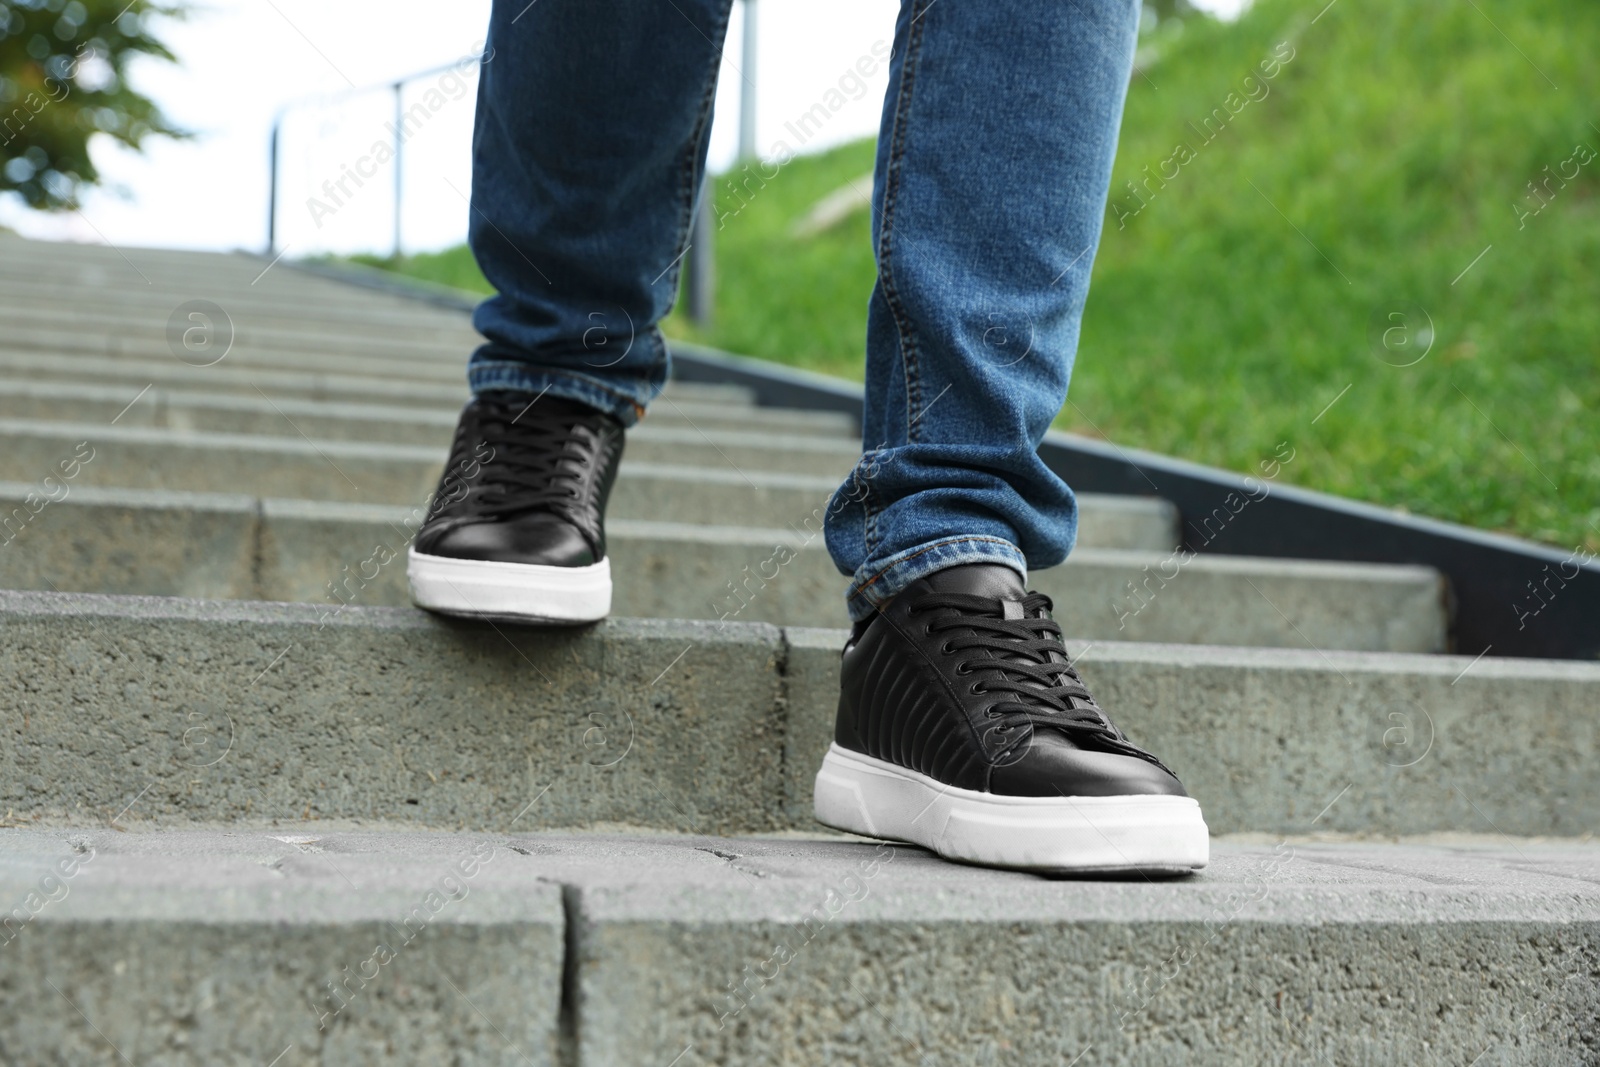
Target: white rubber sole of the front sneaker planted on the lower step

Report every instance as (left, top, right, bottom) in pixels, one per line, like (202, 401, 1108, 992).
(814, 744, 1211, 873)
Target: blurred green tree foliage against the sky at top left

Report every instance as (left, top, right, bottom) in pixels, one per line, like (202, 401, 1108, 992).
(0, 0, 186, 211)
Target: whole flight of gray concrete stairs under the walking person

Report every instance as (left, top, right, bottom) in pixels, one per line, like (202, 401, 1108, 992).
(0, 235, 1600, 1067)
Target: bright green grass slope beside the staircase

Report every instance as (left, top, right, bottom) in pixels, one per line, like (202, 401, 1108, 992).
(356, 0, 1600, 549)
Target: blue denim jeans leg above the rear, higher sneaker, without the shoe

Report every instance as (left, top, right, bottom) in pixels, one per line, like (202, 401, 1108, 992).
(469, 0, 733, 426)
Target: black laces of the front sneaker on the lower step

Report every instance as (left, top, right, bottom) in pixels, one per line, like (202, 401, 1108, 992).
(910, 593, 1162, 766)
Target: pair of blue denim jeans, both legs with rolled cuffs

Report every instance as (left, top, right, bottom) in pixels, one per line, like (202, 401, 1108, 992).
(469, 0, 1139, 619)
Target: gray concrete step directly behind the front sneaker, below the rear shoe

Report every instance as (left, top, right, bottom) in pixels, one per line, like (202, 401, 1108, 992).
(0, 592, 1600, 837)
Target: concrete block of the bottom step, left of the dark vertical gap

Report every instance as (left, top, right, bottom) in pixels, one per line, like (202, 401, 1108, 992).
(0, 831, 566, 1067)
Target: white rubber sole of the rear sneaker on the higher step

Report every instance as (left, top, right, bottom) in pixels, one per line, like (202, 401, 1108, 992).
(405, 549, 611, 624)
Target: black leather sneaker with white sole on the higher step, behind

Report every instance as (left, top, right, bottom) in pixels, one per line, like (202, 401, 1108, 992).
(406, 392, 622, 624)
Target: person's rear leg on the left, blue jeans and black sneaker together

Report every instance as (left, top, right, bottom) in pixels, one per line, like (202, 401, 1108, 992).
(406, 0, 733, 622)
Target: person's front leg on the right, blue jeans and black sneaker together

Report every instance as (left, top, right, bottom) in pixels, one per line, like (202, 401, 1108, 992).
(816, 0, 1210, 872)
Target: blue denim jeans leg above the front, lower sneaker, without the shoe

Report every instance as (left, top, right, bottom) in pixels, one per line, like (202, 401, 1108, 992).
(827, 0, 1139, 619)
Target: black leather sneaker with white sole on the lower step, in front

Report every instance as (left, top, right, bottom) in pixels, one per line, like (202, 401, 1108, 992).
(816, 563, 1211, 873)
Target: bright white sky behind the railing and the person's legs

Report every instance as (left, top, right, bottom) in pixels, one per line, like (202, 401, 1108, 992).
(0, 0, 1245, 256)
